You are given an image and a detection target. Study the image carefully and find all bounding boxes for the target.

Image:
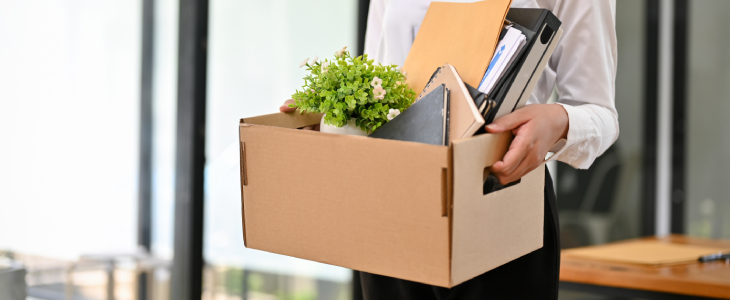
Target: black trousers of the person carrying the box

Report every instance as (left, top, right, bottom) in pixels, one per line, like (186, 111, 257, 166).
(354, 168, 560, 300)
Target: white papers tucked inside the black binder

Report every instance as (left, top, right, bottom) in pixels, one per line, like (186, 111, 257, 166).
(479, 26, 527, 94)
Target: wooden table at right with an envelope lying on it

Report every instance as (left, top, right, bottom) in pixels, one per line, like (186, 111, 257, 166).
(560, 235, 730, 299)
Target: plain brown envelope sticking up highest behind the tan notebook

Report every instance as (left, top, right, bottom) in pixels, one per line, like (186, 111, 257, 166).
(403, 0, 512, 92)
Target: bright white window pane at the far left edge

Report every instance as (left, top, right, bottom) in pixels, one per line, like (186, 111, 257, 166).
(0, 0, 141, 259)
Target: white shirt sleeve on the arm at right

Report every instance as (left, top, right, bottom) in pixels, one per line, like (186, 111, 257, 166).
(543, 0, 619, 169)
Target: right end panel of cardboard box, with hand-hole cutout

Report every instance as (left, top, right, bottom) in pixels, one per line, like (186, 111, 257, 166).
(451, 132, 545, 285)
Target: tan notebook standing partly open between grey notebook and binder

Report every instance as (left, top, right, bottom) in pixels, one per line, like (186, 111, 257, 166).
(417, 64, 484, 141)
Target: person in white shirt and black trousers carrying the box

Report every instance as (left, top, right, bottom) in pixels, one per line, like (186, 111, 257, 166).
(360, 0, 618, 299)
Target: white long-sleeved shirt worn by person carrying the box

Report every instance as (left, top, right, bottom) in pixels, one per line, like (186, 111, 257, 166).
(365, 0, 619, 169)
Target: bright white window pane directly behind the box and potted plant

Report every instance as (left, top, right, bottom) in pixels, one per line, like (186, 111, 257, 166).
(204, 0, 358, 298)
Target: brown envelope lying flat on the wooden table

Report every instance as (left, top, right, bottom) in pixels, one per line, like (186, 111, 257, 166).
(563, 241, 729, 265)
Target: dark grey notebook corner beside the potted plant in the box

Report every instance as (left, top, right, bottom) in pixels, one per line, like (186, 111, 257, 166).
(369, 84, 450, 145)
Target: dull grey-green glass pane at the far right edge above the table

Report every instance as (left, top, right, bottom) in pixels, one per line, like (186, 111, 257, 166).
(684, 0, 730, 239)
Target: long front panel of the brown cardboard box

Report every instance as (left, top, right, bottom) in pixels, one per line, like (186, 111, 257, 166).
(240, 121, 450, 286)
